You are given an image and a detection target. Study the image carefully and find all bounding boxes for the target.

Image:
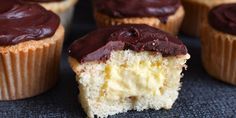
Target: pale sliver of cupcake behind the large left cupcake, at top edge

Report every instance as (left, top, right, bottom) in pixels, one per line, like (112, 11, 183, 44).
(21, 0, 77, 30)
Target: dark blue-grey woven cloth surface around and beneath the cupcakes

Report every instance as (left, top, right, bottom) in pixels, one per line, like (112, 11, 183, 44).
(0, 0, 236, 118)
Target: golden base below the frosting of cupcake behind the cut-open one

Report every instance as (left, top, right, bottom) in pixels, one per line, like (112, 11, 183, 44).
(94, 6, 184, 35)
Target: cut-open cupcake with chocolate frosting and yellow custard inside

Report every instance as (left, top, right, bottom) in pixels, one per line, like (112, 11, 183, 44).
(69, 24, 190, 118)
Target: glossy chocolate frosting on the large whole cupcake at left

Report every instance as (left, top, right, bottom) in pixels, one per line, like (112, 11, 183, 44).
(0, 0, 60, 46)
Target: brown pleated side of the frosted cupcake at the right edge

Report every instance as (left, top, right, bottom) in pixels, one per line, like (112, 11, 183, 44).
(201, 25, 236, 85)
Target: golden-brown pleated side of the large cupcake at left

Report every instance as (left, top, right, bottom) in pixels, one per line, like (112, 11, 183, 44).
(0, 33, 63, 100)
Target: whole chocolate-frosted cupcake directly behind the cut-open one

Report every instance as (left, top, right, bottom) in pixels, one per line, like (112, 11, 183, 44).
(94, 0, 184, 35)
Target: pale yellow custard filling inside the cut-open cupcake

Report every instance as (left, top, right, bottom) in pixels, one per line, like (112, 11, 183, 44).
(100, 51, 166, 100)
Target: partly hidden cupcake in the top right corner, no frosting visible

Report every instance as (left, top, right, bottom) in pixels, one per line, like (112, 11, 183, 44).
(181, 0, 236, 37)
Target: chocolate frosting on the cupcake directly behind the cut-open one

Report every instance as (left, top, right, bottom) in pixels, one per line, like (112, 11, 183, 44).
(95, 0, 181, 22)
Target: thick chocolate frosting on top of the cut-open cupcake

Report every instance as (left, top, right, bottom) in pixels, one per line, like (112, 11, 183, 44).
(69, 25, 187, 62)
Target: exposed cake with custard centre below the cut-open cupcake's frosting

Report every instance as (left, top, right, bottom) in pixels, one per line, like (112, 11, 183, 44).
(70, 50, 190, 117)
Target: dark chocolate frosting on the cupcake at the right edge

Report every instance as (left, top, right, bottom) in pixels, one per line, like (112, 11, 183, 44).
(208, 3, 236, 35)
